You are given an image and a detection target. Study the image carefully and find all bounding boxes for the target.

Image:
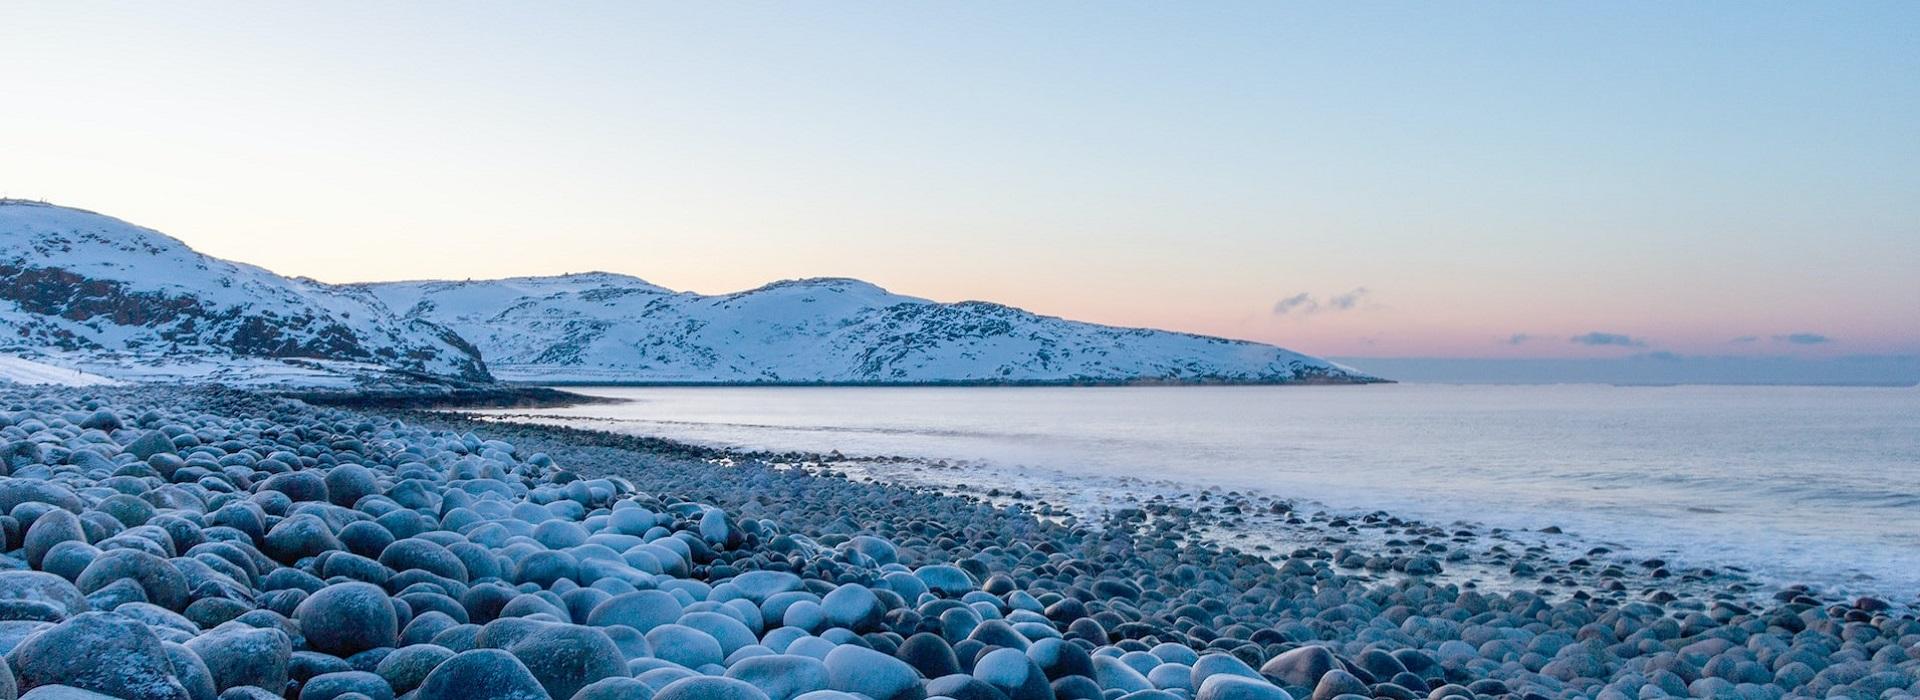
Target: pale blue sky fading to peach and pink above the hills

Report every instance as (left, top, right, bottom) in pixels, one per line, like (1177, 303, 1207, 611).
(0, 2, 1920, 357)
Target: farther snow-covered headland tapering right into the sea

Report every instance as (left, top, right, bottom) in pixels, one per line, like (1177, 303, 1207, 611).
(361, 272, 1371, 384)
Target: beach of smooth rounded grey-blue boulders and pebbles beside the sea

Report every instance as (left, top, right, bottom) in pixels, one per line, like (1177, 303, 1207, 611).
(0, 387, 1920, 700)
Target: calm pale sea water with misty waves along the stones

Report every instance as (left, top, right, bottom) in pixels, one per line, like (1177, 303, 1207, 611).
(468, 384, 1920, 600)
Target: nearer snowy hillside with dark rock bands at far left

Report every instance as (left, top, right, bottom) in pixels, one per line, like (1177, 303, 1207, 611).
(0, 199, 488, 380)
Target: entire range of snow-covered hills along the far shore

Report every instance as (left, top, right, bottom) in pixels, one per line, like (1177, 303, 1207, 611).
(0, 199, 1375, 387)
